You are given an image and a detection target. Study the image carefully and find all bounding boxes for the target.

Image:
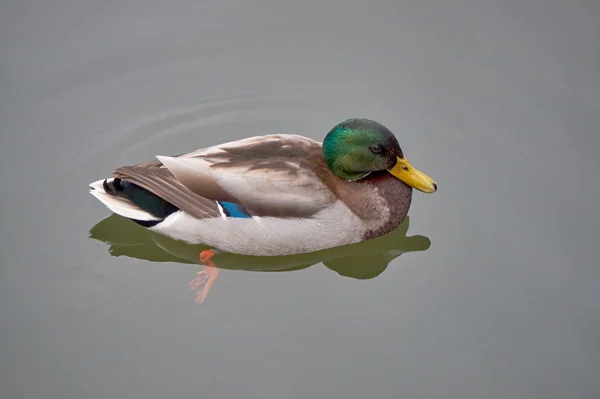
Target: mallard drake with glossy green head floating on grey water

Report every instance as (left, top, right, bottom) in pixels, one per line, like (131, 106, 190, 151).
(90, 119, 437, 265)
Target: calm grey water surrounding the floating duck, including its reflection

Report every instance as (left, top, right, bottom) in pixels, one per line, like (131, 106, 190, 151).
(0, 0, 600, 399)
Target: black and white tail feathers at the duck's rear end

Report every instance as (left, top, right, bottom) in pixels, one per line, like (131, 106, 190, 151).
(90, 178, 179, 227)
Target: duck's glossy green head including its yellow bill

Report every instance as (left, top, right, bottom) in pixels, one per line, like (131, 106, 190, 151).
(323, 119, 437, 193)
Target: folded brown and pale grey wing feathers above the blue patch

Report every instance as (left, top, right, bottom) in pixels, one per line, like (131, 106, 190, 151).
(114, 135, 336, 218)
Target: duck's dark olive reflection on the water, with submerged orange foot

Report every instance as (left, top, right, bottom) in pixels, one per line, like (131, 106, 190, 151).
(90, 214, 431, 303)
